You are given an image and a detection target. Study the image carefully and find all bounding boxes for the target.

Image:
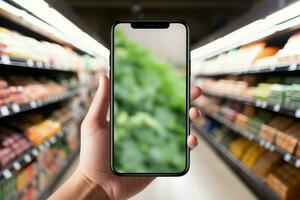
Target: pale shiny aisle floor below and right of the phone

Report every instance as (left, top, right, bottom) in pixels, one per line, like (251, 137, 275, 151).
(132, 133, 256, 200)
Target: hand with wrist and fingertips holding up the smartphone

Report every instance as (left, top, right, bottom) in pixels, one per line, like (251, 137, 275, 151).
(49, 76, 201, 200)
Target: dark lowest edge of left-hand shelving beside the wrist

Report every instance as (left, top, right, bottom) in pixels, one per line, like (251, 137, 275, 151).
(36, 148, 79, 200)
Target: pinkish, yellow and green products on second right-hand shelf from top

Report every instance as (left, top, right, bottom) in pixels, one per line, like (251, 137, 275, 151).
(196, 76, 300, 109)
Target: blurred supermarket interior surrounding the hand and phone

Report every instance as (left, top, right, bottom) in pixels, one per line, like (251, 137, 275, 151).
(0, 0, 300, 200)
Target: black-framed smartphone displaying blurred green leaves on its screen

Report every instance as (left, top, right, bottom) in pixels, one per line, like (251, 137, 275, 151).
(110, 21, 190, 176)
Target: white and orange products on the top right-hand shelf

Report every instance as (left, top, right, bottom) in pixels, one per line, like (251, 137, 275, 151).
(193, 33, 300, 74)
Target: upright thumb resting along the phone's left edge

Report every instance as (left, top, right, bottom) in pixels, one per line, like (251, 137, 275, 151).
(85, 75, 109, 126)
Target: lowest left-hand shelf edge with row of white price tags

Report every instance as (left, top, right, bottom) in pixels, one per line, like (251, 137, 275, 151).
(0, 119, 79, 179)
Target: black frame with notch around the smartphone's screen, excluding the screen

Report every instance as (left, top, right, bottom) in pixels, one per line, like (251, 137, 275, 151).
(109, 20, 191, 177)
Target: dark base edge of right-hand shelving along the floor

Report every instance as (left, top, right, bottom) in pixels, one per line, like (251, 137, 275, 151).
(193, 125, 279, 200)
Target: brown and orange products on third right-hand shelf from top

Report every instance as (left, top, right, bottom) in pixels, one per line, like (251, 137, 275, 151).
(196, 96, 300, 157)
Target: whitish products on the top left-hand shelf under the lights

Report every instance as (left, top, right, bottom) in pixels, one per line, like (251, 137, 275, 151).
(0, 27, 104, 71)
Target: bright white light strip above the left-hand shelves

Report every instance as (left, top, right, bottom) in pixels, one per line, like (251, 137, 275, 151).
(0, 1, 109, 59)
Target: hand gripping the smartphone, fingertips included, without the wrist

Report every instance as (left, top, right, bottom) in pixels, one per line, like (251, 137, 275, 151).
(79, 76, 201, 199)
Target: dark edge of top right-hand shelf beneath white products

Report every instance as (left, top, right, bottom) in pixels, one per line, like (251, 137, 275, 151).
(194, 63, 300, 77)
